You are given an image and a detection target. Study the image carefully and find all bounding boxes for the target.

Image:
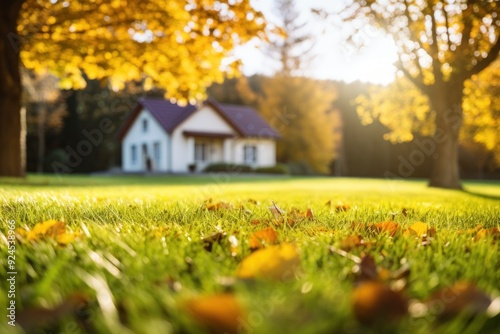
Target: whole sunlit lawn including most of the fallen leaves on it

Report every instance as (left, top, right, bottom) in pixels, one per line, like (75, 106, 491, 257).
(0, 175, 500, 333)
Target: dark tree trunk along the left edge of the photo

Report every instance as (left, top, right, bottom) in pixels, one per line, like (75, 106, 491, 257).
(0, 0, 26, 176)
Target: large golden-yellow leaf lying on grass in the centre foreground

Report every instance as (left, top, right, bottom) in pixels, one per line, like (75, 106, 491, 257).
(236, 244, 300, 280)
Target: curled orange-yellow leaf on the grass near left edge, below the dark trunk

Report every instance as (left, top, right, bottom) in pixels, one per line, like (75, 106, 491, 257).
(16, 219, 80, 246)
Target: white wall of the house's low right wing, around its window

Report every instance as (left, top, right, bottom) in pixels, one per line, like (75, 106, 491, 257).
(233, 138, 276, 167)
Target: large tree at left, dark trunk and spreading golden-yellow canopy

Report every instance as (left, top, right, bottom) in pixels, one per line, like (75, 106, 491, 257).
(0, 0, 265, 176)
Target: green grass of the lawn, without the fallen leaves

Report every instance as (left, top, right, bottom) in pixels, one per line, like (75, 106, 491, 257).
(0, 174, 500, 333)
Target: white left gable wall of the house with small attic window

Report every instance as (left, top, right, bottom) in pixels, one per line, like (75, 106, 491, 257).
(122, 109, 169, 172)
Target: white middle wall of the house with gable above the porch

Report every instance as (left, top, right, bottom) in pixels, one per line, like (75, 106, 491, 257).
(172, 106, 236, 173)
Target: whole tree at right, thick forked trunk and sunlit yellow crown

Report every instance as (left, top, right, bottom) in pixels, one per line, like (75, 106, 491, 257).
(343, 0, 500, 189)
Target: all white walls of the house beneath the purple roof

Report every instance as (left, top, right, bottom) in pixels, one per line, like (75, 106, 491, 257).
(122, 106, 276, 173)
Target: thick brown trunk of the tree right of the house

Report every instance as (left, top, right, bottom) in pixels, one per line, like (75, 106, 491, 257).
(429, 83, 463, 189)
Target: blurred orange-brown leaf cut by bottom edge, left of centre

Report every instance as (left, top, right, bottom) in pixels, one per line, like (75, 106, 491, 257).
(186, 293, 246, 333)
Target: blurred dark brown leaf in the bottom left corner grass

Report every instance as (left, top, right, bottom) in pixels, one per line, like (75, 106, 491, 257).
(16, 293, 88, 333)
